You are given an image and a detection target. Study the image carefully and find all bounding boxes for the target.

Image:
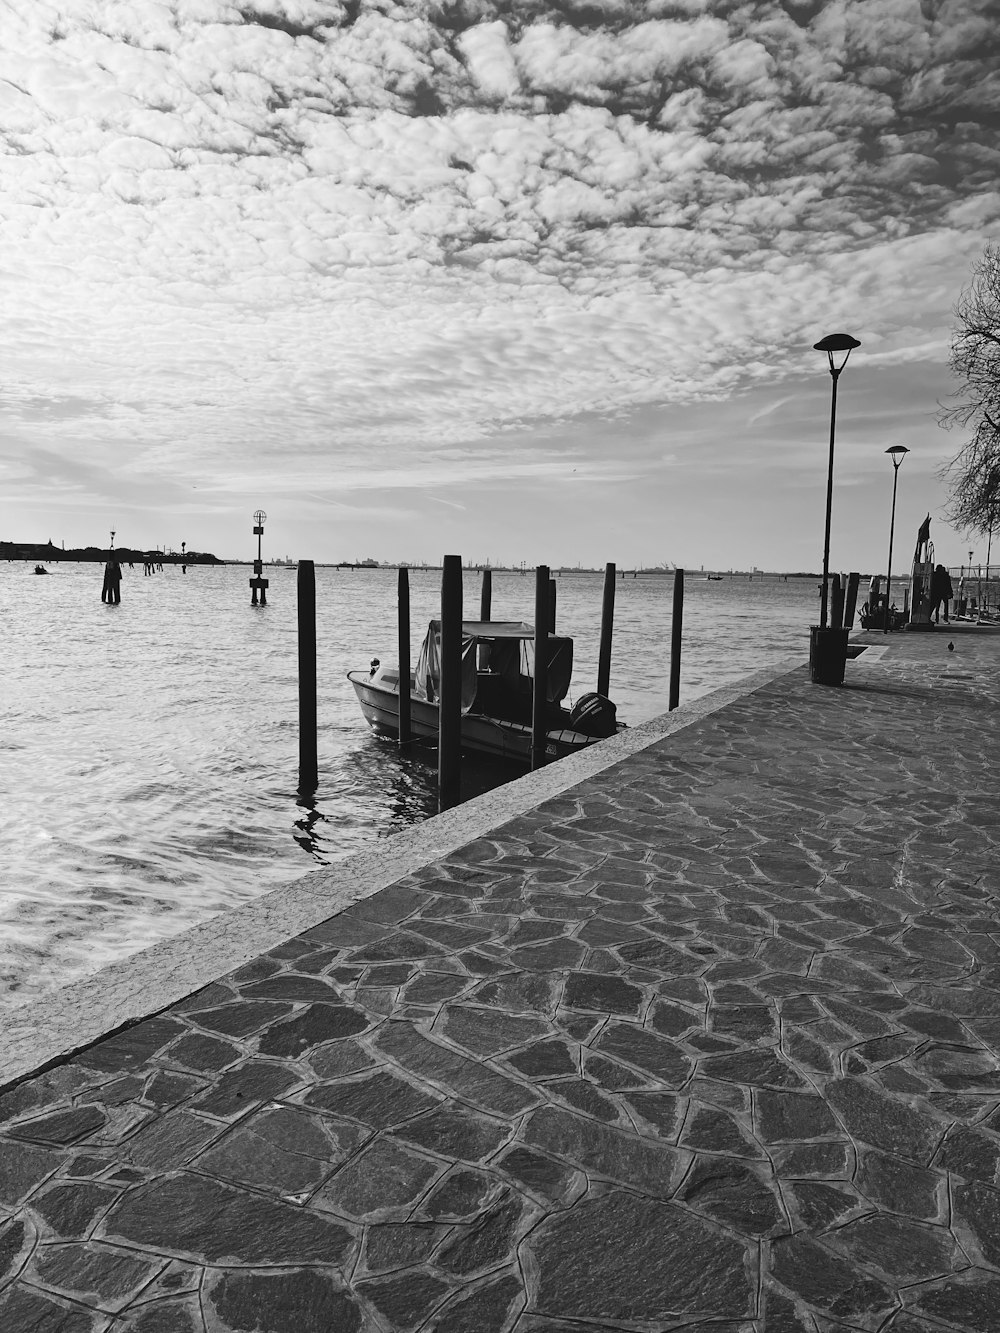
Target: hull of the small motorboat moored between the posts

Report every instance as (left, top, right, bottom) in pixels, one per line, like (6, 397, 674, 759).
(347, 670, 608, 764)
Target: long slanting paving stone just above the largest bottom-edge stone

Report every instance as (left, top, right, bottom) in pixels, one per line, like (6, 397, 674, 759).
(524, 1106, 680, 1198)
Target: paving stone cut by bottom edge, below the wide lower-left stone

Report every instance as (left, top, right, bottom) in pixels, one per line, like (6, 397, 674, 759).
(207, 1268, 363, 1333)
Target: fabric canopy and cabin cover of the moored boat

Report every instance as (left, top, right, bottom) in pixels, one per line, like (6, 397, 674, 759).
(413, 620, 573, 713)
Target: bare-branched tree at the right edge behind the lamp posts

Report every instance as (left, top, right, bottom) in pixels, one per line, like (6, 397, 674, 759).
(939, 243, 1000, 533)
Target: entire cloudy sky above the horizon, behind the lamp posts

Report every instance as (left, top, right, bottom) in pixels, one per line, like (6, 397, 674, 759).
(0, 0, 1000, 571)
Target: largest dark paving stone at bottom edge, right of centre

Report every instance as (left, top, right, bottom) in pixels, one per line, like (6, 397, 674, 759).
(527, 1190, 755, 1326)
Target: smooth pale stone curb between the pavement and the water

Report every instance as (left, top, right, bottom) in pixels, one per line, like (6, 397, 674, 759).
(0, 657, 804, 1092)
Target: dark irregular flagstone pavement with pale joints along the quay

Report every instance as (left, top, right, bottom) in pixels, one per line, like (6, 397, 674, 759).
(0, 625, 1000, 1333)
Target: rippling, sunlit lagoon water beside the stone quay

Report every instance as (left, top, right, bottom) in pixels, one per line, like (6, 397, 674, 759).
(0, 564, 832, 1005)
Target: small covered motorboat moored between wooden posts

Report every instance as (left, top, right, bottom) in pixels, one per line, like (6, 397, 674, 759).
(347, 620, 624, 762)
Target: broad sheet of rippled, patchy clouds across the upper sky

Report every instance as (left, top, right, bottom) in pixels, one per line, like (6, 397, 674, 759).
(0, 0, 1000, 506)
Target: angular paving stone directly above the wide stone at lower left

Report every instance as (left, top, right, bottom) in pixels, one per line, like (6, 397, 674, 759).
(196, 1106, 367, 1194)
